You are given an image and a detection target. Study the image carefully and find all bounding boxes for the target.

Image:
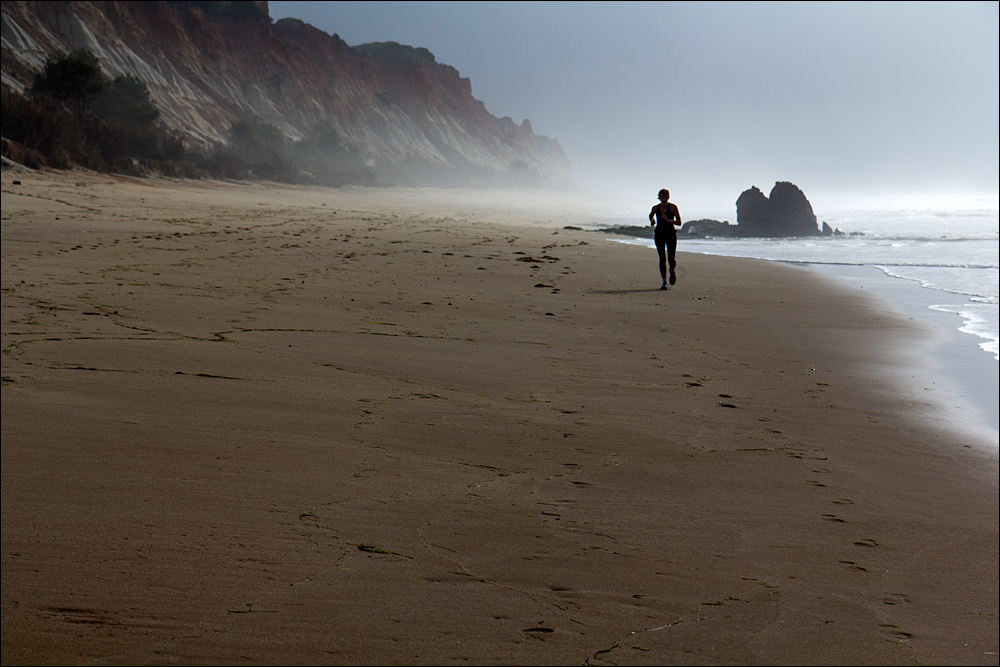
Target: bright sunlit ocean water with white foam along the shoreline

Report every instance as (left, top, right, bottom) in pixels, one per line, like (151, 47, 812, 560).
(602, 201, 1000, 447)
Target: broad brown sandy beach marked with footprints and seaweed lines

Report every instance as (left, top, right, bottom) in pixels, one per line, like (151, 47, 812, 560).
(2, 171, 998, 665)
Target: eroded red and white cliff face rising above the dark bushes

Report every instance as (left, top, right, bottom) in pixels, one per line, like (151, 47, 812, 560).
(2, 2, 570, 185)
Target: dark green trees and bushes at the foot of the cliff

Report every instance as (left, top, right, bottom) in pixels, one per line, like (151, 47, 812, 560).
(2, 49, 373, 185)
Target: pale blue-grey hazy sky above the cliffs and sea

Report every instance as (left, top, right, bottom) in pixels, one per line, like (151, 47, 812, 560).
(269, 2, 1000, 219)
